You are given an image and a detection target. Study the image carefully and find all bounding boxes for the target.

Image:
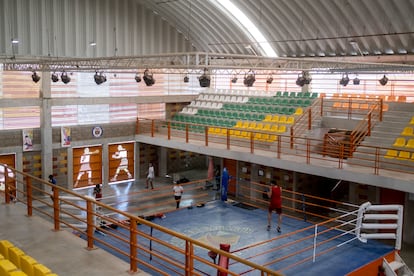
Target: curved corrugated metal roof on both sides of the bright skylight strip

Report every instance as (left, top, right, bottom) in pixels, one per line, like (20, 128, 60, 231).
(137, 0, 414, 57)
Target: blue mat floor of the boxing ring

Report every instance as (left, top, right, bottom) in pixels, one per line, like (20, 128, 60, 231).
(89, 201, 393, 275)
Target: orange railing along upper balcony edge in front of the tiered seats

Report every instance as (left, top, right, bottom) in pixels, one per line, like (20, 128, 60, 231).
(136, 115, 414, 177)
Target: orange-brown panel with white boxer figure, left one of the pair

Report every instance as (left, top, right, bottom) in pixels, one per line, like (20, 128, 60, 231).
(73, 145, 102, 189)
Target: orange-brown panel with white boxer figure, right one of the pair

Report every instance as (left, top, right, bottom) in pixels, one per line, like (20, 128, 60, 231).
(108, 143, 134, 182)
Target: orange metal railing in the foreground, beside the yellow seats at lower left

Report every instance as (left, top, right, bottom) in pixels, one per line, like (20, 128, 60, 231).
(0, 164, 281, 275)
